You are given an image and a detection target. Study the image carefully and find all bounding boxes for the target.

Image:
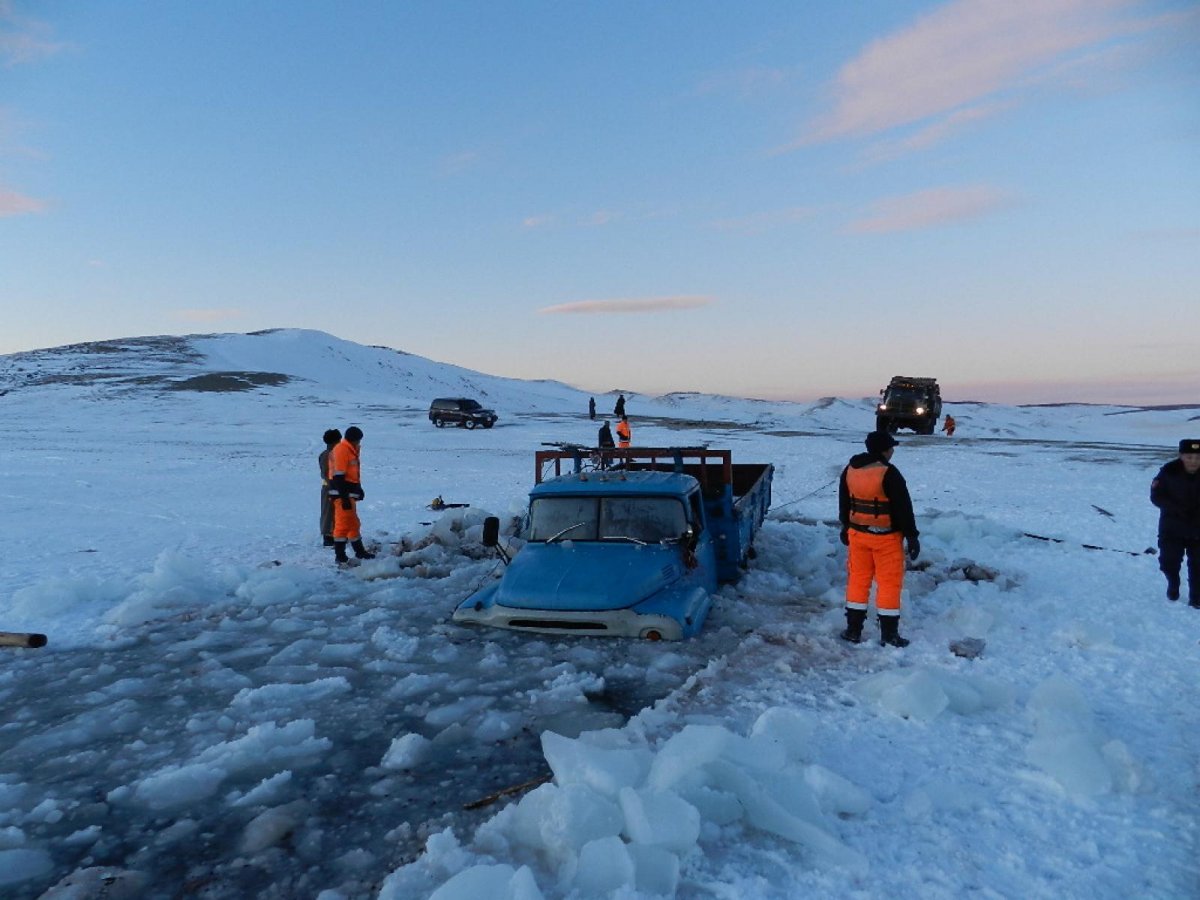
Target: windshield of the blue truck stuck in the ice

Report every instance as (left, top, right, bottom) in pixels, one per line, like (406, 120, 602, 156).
(529, 497, 688, 544)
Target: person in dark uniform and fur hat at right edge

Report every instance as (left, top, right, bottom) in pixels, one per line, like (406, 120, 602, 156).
(1150, 438, 1200, 608)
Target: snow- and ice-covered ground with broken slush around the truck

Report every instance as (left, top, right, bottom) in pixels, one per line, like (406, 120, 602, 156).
(0, 331, 1200, 900)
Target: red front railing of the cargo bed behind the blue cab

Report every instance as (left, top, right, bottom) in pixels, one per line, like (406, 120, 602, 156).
(534, 446, 733, 493)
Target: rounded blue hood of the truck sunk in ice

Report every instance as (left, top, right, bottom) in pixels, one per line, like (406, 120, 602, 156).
(496, 541, 684, 611)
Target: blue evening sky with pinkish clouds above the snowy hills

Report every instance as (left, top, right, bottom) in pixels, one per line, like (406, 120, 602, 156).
(0, 0, 1200, 403)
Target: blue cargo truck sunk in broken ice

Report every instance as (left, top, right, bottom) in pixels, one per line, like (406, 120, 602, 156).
(454, 448, 774, 641)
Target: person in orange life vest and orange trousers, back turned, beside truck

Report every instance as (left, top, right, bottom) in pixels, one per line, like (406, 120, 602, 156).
(838, 431, 920, 647)
